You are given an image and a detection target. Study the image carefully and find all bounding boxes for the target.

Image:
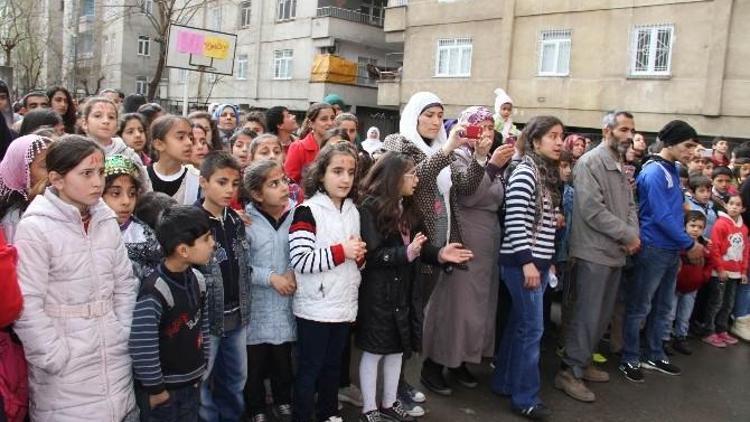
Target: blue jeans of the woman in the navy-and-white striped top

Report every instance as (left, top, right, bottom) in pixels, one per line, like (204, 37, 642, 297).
(492, 265, 549, 409)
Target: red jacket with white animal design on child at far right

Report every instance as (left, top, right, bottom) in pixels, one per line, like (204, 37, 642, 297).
(711, 212, 750, 278)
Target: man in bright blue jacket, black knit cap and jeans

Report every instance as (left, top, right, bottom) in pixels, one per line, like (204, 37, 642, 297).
(620, 120, 704, 382)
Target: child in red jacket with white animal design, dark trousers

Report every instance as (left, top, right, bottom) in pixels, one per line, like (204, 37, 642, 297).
(703, 194, 750, 347)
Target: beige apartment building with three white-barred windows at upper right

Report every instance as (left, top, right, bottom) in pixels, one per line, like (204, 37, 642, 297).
(378, 0, 750, 138)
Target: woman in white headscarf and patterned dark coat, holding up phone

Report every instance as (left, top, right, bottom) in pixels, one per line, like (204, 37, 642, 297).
(383, 92, 485, 402)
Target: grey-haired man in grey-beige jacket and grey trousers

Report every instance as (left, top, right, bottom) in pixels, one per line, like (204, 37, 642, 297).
(555, 111, 641, 402)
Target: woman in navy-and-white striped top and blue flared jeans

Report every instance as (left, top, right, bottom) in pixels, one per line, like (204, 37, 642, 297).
(492, 116, 563, 419)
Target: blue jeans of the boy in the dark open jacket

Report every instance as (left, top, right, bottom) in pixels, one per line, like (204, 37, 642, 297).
(200, 326, 247, 422)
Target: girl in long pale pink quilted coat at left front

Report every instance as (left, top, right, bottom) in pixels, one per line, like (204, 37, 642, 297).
(15, 135, 138, 421)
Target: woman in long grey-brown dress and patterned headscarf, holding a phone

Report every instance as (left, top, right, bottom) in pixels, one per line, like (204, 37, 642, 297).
(423, 106, 514, 388)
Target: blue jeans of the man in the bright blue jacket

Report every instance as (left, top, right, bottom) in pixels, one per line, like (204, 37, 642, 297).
(622, 246, 680, 364)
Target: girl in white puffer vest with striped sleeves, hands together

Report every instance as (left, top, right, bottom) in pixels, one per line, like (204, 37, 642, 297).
(289, 143, 366, 422)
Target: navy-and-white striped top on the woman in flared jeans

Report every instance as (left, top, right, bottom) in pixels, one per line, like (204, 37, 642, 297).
(500, 160, 557, 269)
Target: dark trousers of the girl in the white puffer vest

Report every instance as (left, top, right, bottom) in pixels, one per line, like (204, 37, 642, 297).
(293, 318, 351, 422)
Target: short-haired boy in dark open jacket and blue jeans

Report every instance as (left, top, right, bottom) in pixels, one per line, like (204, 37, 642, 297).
(195, 151, 252, 422)
